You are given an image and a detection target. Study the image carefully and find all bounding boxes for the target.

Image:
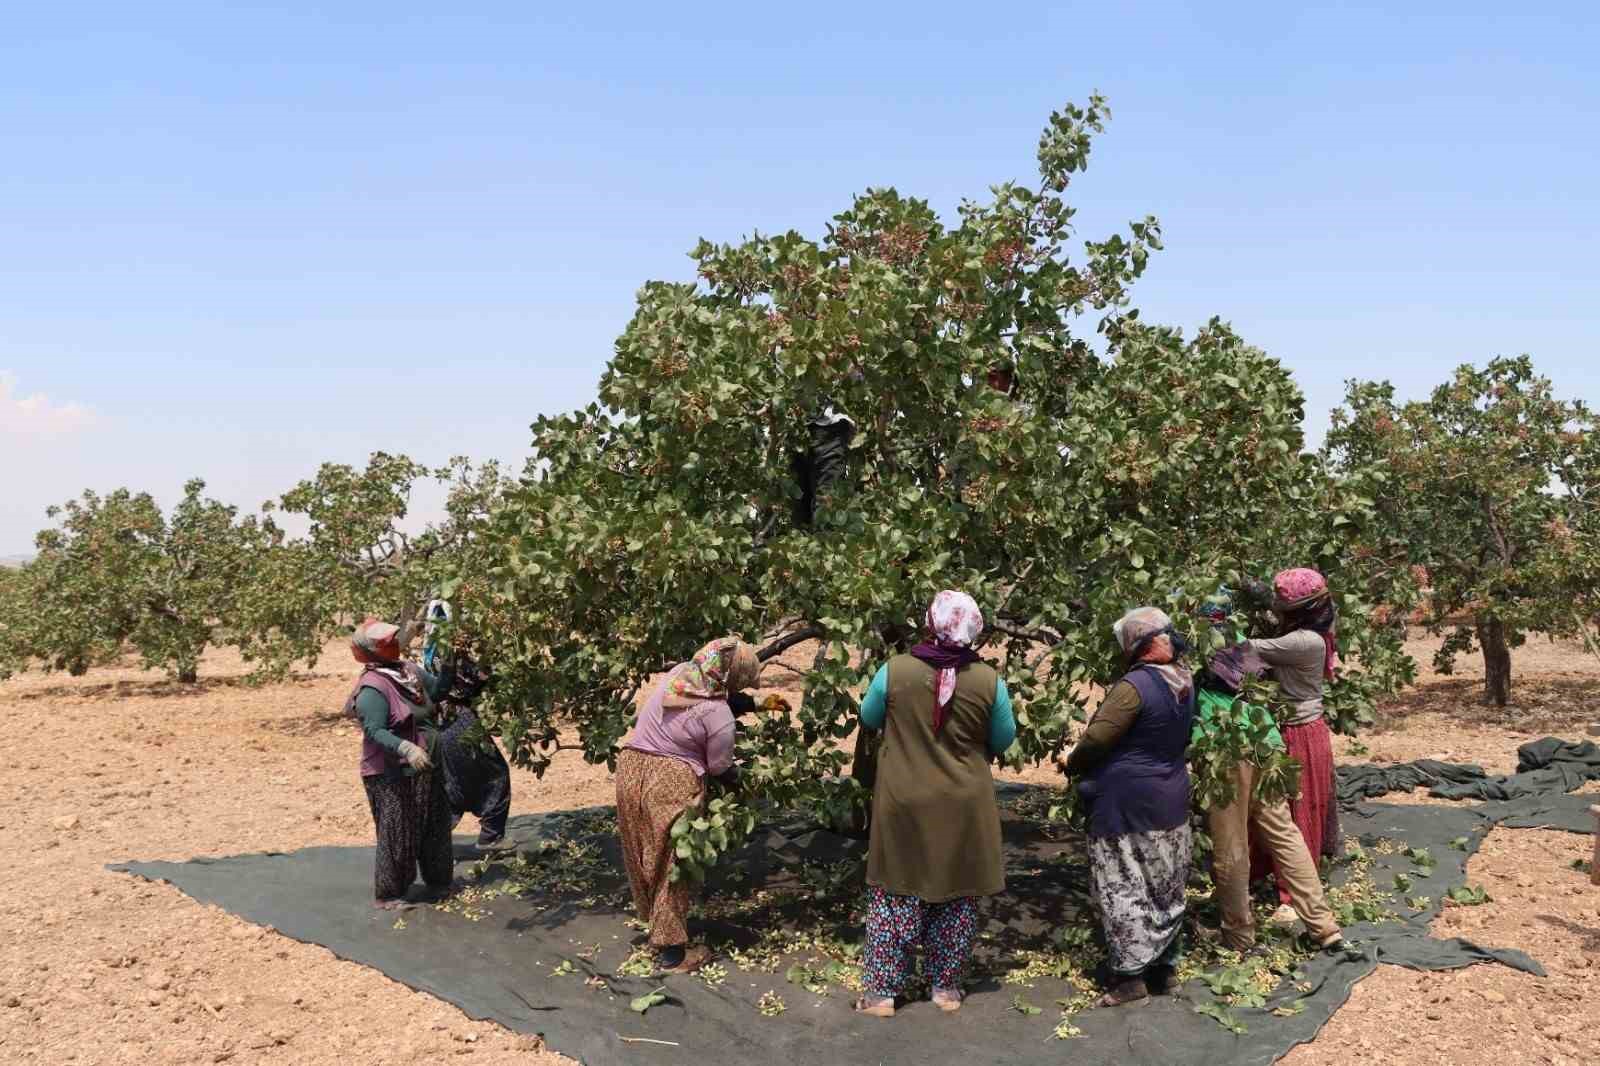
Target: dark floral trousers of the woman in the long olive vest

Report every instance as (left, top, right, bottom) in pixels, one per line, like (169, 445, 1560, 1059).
(862, 885, 978, 999)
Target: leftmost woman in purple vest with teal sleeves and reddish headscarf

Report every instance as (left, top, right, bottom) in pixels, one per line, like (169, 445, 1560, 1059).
(346, 618, 456, 909)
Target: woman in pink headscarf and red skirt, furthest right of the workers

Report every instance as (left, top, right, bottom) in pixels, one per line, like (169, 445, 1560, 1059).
(1250, 567, 1339, 924)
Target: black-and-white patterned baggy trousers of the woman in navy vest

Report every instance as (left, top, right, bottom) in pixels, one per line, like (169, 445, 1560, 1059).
(1088, 823, 1192, 976)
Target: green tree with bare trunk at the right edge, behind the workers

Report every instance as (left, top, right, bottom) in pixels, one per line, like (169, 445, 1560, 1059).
(1326, 355, 1600, 706)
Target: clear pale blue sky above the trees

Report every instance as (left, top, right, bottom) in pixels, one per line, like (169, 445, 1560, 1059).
(0, 8, 1600, 555)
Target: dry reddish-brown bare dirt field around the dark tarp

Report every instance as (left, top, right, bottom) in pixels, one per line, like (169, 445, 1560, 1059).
(0, 642, 1600, 1066)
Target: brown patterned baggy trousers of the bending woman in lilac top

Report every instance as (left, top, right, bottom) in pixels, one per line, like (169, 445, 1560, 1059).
(616, 747, 702, 948)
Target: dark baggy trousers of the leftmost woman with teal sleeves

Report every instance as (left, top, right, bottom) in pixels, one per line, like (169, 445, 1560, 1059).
(362, 770, 456, 903)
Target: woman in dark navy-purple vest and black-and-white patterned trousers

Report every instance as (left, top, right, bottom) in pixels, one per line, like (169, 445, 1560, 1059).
(1058, 607, 1195, 1007)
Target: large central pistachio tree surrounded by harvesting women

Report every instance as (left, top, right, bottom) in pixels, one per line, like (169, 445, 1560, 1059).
(446, 98, 1400, 858)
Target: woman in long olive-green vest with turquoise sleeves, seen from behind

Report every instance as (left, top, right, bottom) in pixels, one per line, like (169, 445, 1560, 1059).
(856, 591, 1016, 1018)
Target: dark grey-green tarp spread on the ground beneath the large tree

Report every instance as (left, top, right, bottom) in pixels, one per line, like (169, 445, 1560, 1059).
(114, 771, 1539, 1066)
